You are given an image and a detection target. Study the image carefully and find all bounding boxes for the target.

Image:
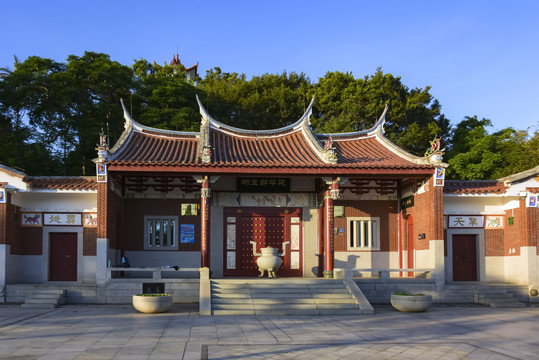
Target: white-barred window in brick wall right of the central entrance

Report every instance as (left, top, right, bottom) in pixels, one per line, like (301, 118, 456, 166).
(347, 217, 380, 250)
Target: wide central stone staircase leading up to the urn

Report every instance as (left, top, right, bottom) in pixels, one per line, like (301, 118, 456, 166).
(211, 278, 372, 316)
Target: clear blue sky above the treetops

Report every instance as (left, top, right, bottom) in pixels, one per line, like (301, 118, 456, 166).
(0, 0, 539, 131)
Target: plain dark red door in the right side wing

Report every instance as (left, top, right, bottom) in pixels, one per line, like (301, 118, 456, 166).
(453, 235, 477, 281)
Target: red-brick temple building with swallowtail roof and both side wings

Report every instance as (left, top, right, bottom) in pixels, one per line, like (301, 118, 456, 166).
(0, 99, 539, 310)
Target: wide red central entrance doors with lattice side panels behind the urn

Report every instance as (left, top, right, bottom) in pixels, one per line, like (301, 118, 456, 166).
(224, 208, 302, 277)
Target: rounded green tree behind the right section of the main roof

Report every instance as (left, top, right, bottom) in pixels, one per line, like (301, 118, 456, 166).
(313, 68, 450, 156)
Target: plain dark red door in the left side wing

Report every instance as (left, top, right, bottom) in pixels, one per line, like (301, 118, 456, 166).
(49, 233, 77, 281)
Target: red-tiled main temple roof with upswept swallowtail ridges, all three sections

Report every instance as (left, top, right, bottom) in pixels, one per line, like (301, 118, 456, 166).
(106, 99, 445, 172)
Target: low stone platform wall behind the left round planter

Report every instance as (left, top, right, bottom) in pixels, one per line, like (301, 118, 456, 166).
(105, 279, 200, 304)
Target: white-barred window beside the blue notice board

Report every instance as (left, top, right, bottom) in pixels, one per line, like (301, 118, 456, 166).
(144, 216, 178, 250)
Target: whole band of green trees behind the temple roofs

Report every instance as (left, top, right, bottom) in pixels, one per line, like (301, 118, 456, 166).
(0, 52, 539, 179)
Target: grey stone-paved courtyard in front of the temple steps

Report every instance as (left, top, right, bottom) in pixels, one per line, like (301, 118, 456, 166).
(0, 305, 539, 360)
